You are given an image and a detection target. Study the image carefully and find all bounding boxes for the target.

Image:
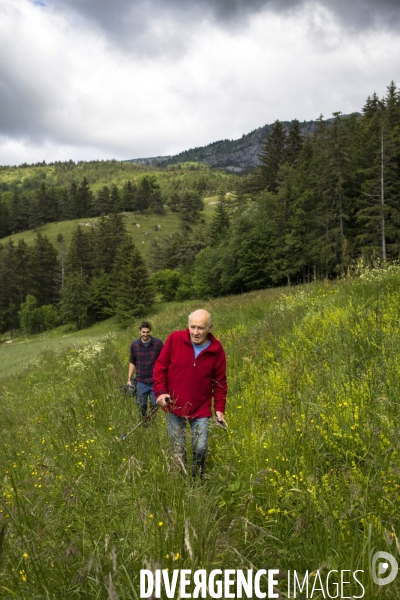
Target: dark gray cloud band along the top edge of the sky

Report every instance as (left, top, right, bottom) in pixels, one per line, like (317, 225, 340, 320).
(46, 0, 400, 48)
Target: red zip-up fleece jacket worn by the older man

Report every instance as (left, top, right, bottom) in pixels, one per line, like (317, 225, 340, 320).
(153, 329, 228, 419)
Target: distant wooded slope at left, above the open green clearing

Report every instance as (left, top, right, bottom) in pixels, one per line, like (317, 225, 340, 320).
(0, 161, 236, 239)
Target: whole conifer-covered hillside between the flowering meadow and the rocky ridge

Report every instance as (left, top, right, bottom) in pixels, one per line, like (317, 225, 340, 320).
(0, 82, 400, 333)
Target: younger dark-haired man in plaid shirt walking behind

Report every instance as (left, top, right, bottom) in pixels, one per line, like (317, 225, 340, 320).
(128, 321, 163, 417)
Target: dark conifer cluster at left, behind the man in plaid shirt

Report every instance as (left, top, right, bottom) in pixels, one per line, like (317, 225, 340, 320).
(0, 213, 154, 333)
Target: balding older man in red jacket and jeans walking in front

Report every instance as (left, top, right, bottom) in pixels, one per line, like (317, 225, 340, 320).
(153, 309, 227, 475)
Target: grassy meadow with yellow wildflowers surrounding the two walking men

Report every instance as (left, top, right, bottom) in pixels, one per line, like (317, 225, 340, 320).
(0, 266, 400, 600)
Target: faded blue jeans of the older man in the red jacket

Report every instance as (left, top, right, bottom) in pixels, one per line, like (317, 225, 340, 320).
(165, 413, 210, 477)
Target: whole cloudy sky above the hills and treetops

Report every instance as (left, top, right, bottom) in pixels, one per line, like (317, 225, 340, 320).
(0, 0, 400, 165)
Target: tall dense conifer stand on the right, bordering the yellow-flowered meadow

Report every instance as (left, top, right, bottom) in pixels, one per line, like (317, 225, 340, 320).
(183, 82, 400, 297)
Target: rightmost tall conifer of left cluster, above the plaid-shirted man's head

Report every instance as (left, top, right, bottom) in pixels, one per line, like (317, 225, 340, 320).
(112, 238, 154, 323)
